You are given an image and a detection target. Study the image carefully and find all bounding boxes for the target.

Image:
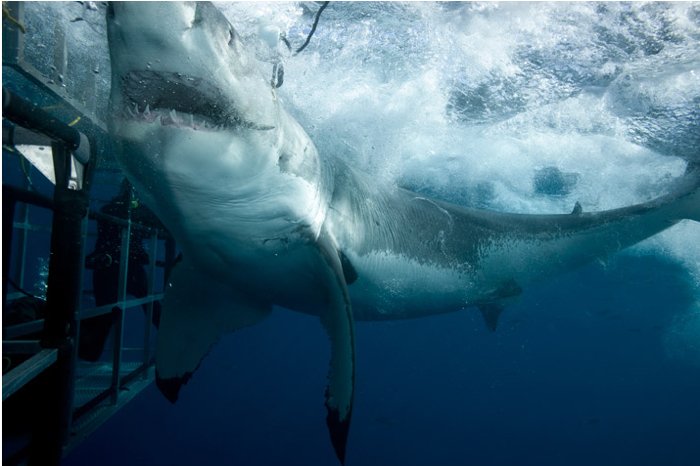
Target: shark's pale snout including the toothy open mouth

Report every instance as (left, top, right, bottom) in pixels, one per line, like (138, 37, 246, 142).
(106, 2, 274, 131)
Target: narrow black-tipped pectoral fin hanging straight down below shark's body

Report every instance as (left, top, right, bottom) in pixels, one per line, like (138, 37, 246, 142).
(318, 228, 355, 464)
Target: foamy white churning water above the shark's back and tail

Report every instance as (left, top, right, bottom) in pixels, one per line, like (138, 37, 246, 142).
(223, 3, 700, 361)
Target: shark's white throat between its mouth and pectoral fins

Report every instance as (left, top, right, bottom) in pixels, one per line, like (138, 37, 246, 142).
(122, 123, 326, 307)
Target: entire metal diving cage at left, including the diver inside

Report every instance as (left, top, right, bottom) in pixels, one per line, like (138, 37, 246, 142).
(2, 2, 175, 465)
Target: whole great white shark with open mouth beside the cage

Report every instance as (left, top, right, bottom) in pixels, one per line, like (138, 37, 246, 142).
(107, 2, 700, 462)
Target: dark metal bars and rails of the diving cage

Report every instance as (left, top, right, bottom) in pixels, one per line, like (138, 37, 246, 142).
(2, 2, 174, 465)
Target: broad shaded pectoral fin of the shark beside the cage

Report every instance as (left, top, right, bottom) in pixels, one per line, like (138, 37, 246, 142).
(156, 257, 270, 403)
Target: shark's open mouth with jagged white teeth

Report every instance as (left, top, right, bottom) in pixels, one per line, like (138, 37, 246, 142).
(122, 70, 274, 131)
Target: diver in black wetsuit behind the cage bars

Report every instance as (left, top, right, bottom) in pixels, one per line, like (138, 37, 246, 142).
(78, 180, 163, 361)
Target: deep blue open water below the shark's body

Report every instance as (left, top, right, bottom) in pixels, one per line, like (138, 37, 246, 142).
(65, 256, 700, 466)
